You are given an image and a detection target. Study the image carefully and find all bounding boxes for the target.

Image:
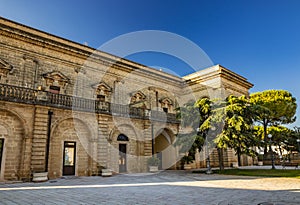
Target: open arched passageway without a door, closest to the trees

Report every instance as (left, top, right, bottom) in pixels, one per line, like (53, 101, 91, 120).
(154, 128, 176, 169)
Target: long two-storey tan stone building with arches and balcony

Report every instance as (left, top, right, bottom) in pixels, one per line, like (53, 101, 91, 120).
(0, 18, 252, 180)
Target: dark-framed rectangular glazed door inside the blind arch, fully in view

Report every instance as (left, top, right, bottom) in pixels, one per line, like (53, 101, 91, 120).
(63, 142, 76, 175)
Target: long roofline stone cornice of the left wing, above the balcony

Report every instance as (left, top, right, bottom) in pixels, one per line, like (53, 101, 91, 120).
(0, 17, 182, 84)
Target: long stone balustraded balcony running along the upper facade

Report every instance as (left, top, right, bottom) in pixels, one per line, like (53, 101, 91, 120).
(0, 84, 180, 123)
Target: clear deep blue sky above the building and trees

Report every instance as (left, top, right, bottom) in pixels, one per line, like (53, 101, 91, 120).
(0, 0, 300, 126)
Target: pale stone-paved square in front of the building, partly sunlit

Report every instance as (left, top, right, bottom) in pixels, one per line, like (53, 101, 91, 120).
(0, 171, 300, 205)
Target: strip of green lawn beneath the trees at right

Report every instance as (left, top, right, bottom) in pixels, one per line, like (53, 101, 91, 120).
(214, 169, 300, 179)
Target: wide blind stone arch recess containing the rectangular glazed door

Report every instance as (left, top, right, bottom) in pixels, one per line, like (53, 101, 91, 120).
(48, 118, 92, 178)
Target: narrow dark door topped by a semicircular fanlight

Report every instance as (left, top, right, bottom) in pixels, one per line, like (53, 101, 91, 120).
(117, 134, 129, 173)
